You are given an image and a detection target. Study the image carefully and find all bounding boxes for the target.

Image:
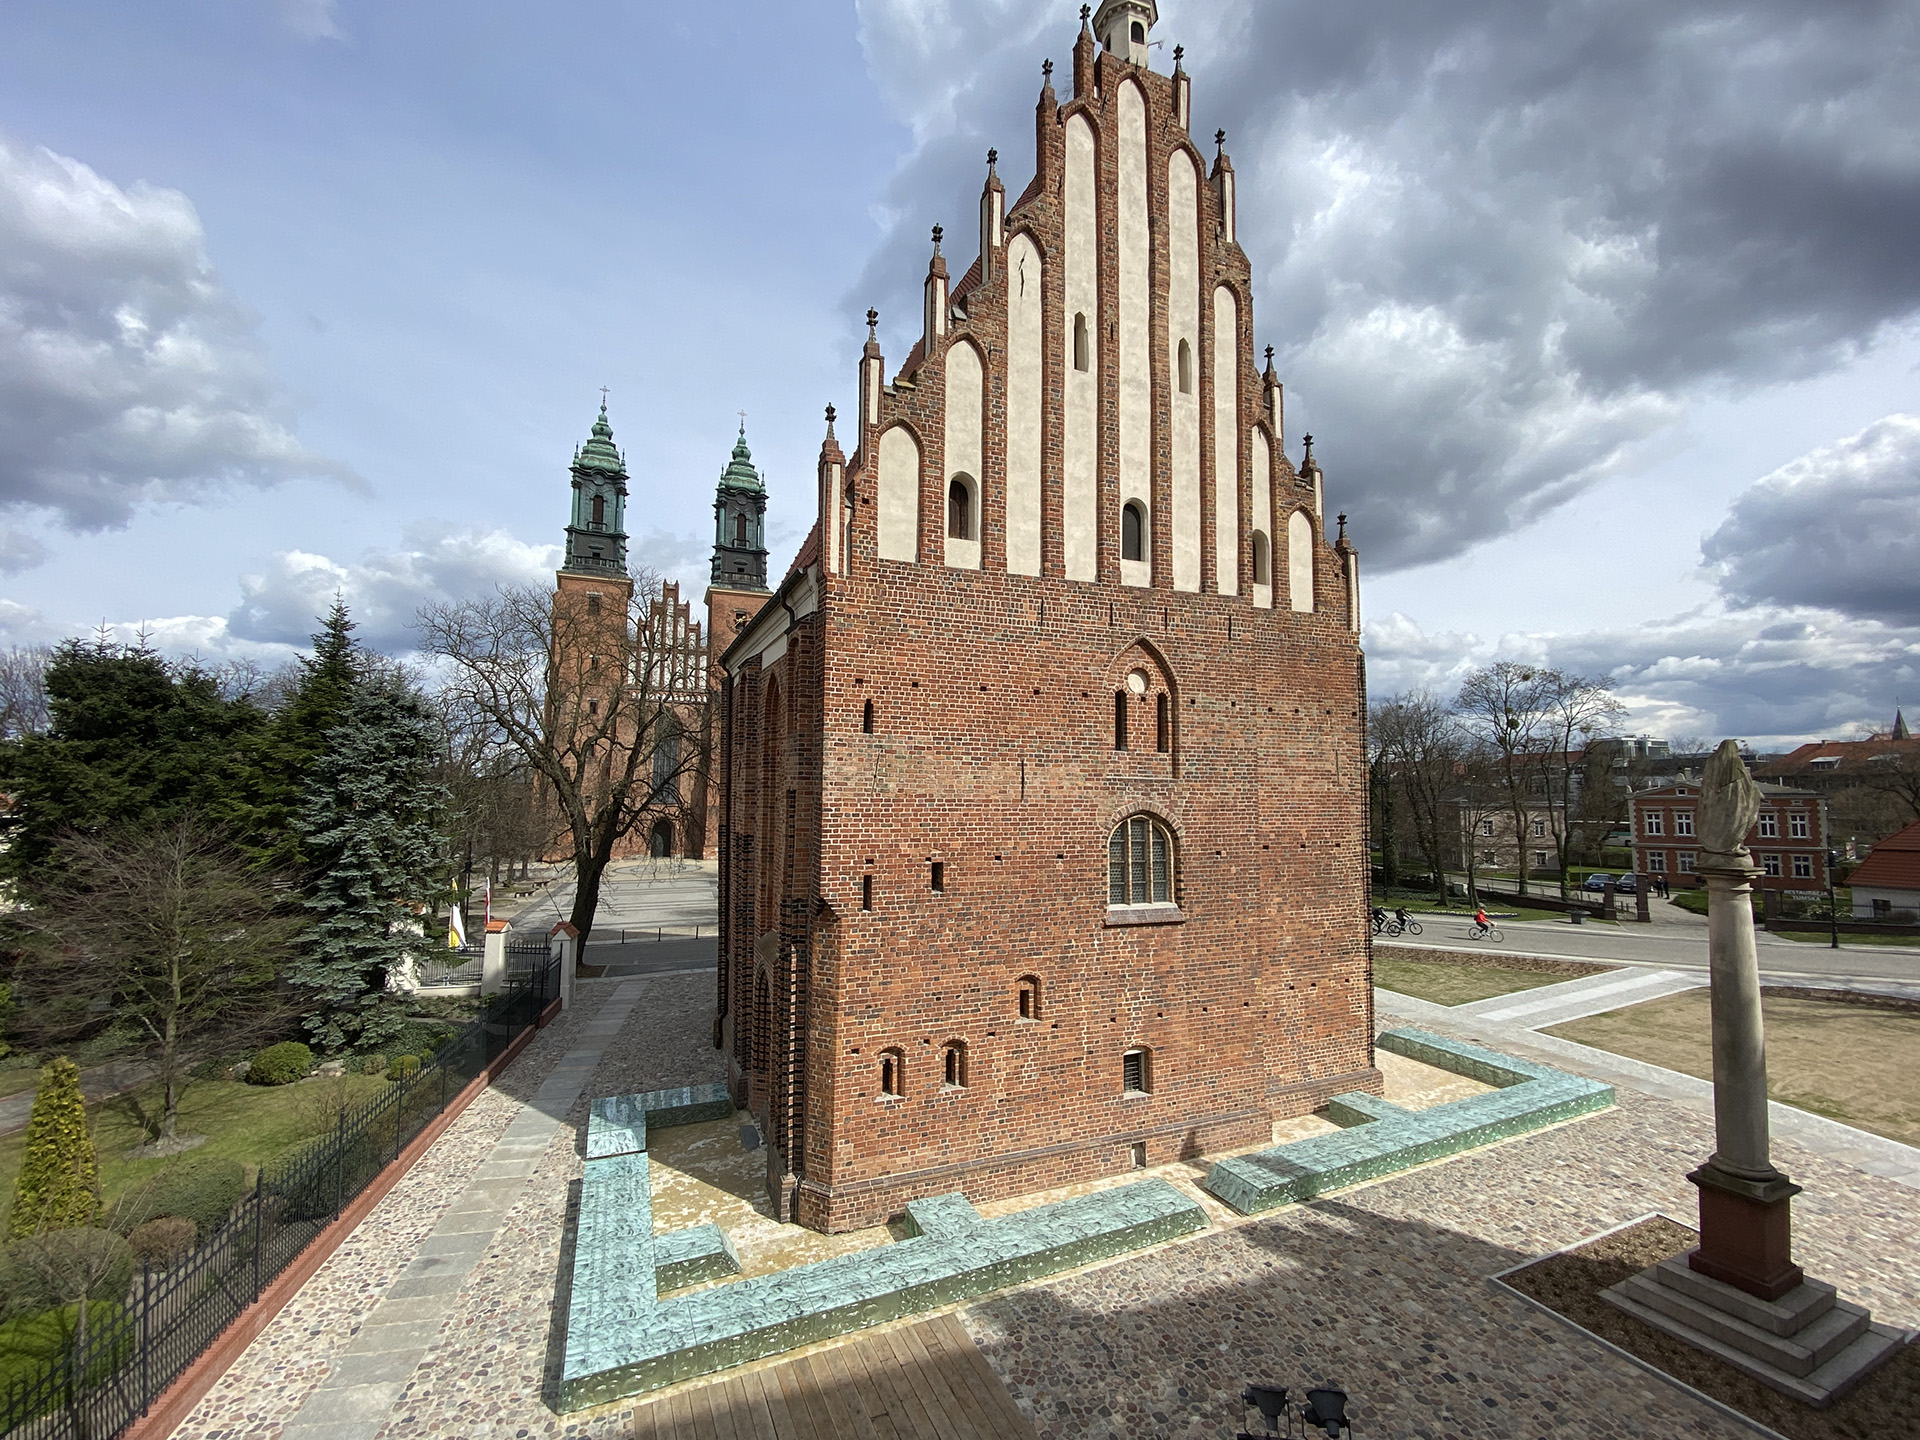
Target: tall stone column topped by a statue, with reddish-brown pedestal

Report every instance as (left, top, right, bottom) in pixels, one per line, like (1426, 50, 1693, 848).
(1688, 741, 1803, 1300)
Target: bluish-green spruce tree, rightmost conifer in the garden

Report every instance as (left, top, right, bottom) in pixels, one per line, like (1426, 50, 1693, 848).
(288, 684, 445, 1050)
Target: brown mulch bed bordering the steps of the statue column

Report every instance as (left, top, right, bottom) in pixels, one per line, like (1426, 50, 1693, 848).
(1503, 1217, 1920, 1440)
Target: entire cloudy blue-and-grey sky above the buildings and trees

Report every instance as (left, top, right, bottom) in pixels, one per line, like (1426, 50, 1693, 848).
(0, 0, 1920, 743)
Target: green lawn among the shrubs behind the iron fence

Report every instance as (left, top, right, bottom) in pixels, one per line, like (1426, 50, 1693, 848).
(0, 1071, 386, 1236)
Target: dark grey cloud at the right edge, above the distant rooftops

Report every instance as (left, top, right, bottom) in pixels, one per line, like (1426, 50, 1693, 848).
(1701, 415, 1920, 626)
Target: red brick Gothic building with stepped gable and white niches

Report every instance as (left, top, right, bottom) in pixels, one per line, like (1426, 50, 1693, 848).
(714, 0, 1379, 1231)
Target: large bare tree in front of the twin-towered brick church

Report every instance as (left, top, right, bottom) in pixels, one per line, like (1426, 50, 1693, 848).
(417, 576, 707, 943)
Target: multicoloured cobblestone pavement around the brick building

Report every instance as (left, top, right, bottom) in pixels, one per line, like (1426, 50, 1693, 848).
(180, 973, 1920, 1440)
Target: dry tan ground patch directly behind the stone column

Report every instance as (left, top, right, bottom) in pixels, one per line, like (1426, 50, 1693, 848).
(1546, 989, 1920, 1144)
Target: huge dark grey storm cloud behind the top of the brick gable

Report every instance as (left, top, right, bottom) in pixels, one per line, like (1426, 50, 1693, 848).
(849, 0, 1920, 568)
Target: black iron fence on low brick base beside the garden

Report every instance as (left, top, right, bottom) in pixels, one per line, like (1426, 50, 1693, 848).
(0, 943, 561, 1440)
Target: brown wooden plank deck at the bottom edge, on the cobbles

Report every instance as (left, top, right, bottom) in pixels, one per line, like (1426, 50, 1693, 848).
(634, 1315, 1035, 1440)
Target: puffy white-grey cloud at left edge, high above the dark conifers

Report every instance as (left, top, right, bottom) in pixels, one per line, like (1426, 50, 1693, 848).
(0, 140, 353, 570)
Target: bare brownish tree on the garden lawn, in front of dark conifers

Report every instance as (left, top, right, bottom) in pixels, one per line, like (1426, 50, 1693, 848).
(13, 820, 298, 1142)
